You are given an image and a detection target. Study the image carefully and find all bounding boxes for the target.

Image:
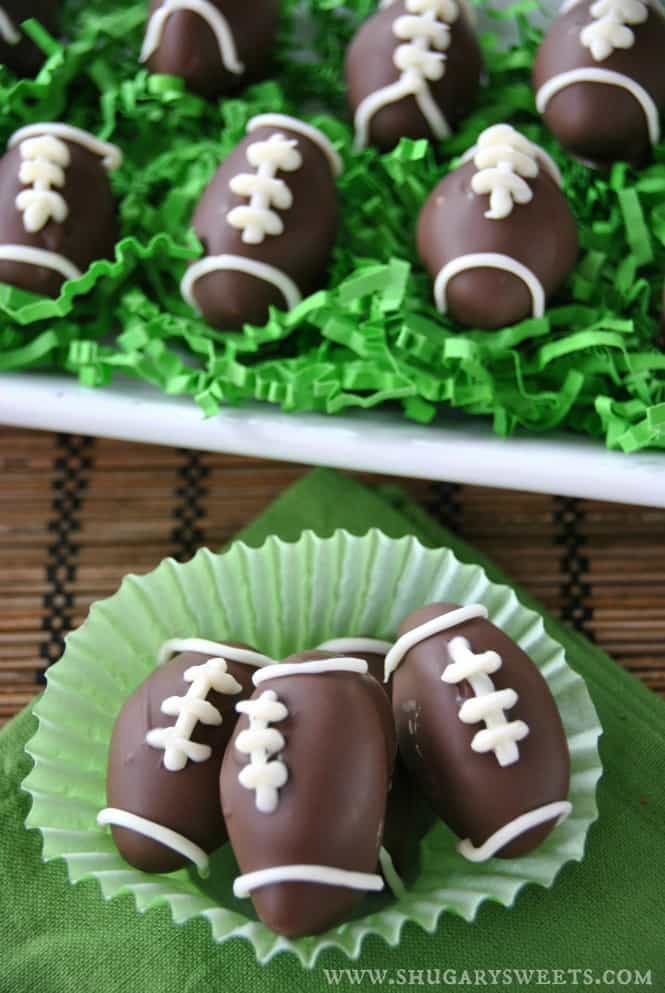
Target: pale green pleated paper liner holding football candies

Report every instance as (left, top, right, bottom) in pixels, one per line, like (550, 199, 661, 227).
(23, 530, 602, 967)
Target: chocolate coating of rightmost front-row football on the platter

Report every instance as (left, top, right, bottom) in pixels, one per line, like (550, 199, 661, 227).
(417, 160, 578, 329)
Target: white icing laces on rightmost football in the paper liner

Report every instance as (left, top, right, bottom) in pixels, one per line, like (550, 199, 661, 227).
(441, 637, 529, 766)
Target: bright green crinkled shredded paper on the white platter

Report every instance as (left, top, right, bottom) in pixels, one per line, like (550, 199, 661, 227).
(0, 0, 665, 452)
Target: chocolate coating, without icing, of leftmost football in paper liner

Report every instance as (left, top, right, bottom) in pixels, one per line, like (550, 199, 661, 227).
(106, 642, 255, 872)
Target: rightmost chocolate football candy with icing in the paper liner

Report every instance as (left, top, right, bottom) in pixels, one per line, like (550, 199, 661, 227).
(386, 603, 571, 862)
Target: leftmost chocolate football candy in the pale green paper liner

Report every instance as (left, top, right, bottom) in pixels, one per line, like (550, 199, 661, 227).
(97, 638, 273, 875)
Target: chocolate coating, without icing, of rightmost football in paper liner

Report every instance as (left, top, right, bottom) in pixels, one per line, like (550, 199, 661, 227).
(393, 604, 570, 858)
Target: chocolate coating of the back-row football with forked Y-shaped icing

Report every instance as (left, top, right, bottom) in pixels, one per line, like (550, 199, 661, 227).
(346, 0, 483, 150)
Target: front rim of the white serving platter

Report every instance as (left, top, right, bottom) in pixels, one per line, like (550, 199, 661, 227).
(0, 373, 665, 507)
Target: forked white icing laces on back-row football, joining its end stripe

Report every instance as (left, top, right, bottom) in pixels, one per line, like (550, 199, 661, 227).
(355, 0, 459, 147)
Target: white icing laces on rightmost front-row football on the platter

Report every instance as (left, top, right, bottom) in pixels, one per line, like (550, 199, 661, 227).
(471, 124, 539, 221)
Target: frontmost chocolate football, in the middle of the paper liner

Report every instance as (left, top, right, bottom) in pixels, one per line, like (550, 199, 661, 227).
(220, 653, 395, 938)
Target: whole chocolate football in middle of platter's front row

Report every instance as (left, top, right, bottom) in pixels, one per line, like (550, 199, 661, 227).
(181, 114, 342, 329)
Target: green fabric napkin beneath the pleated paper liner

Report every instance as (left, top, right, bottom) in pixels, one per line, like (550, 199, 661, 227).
(0, 470, 665, 993)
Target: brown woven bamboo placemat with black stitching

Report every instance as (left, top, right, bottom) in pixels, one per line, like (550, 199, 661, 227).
(0, 428, 665, 723)
